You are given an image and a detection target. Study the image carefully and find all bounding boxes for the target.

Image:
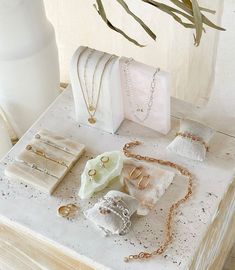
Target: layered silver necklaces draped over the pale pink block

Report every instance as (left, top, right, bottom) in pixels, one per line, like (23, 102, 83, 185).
(124, 58, 160, 123)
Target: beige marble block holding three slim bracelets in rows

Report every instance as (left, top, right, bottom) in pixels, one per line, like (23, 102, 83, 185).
(5, 130, 85, 194)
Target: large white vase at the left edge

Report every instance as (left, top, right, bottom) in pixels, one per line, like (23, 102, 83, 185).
(0, 0, 60, 137)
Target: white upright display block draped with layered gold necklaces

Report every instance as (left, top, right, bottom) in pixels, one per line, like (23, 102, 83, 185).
(70, 47, 124, 133)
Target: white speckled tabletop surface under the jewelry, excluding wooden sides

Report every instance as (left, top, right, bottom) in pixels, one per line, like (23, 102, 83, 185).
(0, 87, 235, 270)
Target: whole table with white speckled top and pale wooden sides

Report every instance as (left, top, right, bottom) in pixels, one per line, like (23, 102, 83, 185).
(0, 89, 235, 270)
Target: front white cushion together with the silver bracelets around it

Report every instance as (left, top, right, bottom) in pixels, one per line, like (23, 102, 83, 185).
(84, 190, 137, 236)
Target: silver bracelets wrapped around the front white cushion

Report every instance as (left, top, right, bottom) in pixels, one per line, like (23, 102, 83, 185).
(99, 197, 131, 235)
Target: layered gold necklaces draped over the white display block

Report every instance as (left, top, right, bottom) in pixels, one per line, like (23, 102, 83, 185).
(77, 47, 113, 124)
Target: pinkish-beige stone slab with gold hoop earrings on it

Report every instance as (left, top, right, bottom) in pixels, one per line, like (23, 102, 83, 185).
(120, 159, 175, 216)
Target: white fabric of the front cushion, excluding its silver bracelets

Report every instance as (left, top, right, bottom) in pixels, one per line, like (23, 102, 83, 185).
(84, 190, 138, 234)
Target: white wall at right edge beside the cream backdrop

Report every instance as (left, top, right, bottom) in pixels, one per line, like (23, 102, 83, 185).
(174, 0, 235, 136)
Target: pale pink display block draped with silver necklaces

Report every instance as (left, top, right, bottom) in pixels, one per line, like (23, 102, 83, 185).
(120, 57, 170, 134)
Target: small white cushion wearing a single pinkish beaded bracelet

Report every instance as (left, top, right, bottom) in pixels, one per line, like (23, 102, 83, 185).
(167, 119, 215, 161)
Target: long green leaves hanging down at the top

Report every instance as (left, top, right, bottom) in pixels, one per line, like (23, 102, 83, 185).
(94, 0, 225, 47)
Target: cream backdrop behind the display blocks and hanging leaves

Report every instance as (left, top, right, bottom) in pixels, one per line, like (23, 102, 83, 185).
(44, 0, 223, 104)
